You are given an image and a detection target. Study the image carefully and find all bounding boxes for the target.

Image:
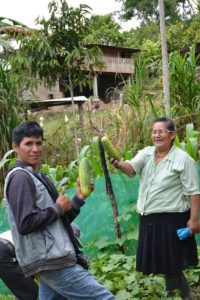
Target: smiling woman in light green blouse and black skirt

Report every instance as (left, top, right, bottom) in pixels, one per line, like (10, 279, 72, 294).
(110, 117, 200, 299)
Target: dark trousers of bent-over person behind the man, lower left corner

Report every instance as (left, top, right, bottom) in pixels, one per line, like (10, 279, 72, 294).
(0, 242, 38, 300)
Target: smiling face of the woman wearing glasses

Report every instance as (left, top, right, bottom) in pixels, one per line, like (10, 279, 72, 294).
(151, 122, 175, 151)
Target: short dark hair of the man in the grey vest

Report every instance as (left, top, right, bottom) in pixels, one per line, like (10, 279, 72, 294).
(12, 121, 43, 146)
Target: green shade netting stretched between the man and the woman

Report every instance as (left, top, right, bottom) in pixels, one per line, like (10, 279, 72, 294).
(67, 174, 139, 253)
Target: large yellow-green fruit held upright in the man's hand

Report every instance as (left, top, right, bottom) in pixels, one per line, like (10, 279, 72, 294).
(79, 157, 92, 197)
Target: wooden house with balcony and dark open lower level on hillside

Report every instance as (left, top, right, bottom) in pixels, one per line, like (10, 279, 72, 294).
(25, 45, 140, 102)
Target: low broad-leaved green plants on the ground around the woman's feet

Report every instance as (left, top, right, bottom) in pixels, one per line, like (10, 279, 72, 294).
(90, 248, 200, 300)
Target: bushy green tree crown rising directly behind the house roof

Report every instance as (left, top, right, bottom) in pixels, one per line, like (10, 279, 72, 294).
(86, 14, 125, 46)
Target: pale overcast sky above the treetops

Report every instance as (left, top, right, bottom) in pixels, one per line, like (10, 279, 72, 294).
(0, 0, 136, 29)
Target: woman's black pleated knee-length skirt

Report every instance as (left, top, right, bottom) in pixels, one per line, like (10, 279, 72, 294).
(136, 211, 198, 274)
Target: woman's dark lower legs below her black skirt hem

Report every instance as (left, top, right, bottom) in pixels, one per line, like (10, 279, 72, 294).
(165, 272, 193, 300)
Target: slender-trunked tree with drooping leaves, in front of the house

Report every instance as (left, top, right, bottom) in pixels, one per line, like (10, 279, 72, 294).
(12, 0, 102, 157)
